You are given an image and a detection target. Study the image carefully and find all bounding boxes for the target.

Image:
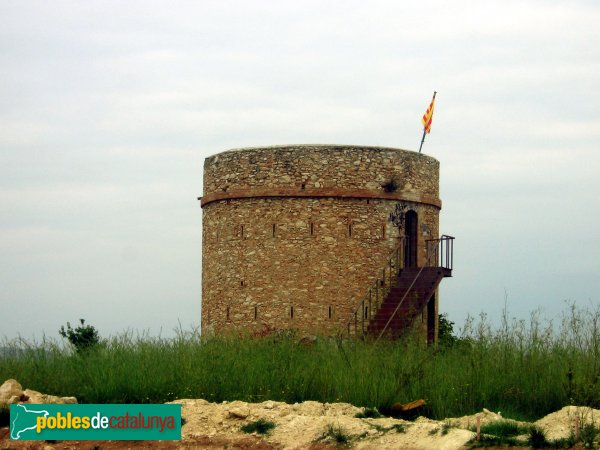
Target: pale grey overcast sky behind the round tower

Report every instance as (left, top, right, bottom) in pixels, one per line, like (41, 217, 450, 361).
(0, 0, 600, 339)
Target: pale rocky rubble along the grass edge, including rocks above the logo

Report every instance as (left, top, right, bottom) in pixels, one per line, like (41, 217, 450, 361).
(0, 379, 600, 450)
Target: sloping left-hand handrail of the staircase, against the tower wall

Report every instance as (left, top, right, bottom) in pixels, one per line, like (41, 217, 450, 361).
(348, 236, 407, 336)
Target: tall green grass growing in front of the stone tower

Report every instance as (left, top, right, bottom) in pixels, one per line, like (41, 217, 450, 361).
(0, 305, 600, 420)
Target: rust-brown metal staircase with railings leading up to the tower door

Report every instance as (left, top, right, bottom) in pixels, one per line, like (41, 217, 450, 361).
(347, 235, 454, 339)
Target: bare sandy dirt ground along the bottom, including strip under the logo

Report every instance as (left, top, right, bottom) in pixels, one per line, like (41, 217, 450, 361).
(0, 399, 600, 450)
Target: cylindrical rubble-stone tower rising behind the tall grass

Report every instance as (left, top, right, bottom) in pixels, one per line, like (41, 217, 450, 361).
(201, 145, 441, 334)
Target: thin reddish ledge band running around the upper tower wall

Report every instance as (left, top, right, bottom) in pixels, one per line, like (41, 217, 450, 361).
(198, 188, 442, 209)
